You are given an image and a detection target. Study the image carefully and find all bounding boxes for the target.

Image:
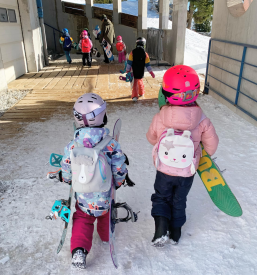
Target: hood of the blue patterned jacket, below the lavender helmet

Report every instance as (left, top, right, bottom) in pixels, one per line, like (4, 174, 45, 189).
(74, 127, 110, 148)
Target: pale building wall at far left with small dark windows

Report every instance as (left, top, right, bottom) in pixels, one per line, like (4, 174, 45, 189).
(0, 0, 27, 88)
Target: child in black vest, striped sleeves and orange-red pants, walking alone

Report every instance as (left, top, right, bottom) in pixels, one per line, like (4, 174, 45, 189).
(126, 37, 155, 101)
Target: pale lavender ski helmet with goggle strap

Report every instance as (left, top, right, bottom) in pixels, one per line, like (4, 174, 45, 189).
(73, 93, 107, 127)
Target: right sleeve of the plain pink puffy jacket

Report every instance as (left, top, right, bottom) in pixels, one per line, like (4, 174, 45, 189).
(201, 118, 219, 156)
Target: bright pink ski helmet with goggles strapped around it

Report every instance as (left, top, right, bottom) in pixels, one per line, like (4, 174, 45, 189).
(162, 65, 200, 105)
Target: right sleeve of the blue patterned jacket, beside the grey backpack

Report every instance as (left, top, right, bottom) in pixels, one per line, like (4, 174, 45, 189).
(103, 139, 128, 190)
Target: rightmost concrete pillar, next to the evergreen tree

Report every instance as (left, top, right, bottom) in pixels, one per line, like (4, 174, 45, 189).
(172, 0, 188, 65)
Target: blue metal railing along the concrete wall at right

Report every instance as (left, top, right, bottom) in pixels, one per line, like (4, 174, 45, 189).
(204, 38, 257, 120)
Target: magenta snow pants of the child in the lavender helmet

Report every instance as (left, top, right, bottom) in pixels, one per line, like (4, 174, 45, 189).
(71, 204, 109, 252)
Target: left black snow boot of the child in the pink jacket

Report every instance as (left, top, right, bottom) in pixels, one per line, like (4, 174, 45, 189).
(152, 216, 169, 247)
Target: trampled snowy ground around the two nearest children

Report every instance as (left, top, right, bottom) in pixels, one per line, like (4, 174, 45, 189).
(0, 96, 257, 275)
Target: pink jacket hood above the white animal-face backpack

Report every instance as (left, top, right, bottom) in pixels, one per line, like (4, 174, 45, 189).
(160, 106, 203, 131)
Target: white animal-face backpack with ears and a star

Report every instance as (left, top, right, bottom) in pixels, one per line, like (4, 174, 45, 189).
(154, 129, 196, 175)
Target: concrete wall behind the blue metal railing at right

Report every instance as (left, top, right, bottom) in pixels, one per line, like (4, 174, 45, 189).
(207, 0, 257, 125)
